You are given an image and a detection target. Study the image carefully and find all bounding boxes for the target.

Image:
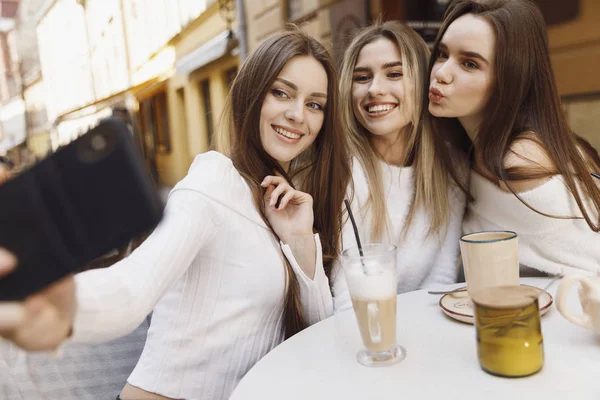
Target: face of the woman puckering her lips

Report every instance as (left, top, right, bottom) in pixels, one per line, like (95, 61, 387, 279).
(429, 14, 494, 131)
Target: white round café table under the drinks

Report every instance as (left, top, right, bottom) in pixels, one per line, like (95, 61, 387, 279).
(230, 278, 600, 400)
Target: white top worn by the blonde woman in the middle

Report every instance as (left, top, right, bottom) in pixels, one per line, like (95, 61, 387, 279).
(332, 159, 466, 312)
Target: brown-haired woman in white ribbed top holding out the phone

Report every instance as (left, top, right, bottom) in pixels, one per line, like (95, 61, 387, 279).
(0, 29, 350, 400)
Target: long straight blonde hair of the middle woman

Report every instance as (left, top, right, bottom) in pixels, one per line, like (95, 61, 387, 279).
(340, 21, 460, 241)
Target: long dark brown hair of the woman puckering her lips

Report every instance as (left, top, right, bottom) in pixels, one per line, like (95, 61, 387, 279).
(429, 0, 600, 232)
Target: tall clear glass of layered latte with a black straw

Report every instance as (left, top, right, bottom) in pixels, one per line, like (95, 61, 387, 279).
(341, 243, 406, 366)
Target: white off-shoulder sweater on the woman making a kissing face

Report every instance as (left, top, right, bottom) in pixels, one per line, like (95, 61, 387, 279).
(463, 172, 600, 274)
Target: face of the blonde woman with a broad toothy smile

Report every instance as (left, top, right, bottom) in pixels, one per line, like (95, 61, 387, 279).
(352, 38, 415, 138)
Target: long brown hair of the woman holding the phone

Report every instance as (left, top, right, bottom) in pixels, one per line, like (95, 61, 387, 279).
(215, 26, 350, 337)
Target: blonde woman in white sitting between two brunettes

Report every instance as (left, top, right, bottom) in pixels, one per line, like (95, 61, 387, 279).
(334, 21, 466, 311)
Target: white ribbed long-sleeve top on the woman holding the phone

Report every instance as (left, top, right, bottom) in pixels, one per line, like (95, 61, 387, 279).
(72, 152, 333, 400)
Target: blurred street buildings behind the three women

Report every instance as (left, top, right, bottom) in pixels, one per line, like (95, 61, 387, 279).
(0, 0, 600, 188)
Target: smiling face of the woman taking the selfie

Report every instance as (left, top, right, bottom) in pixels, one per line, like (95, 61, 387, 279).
(260, 56, 328, 170)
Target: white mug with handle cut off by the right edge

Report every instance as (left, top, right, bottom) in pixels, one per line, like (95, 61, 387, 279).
(556, 275, 600, 334)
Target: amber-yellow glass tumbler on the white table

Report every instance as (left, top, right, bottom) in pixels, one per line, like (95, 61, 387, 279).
(471, 286, 544, 378)
